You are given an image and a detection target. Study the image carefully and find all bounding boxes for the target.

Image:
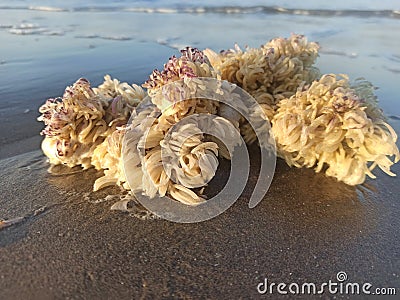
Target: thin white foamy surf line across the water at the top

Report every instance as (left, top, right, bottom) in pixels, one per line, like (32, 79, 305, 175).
(0, 6, 400, 18)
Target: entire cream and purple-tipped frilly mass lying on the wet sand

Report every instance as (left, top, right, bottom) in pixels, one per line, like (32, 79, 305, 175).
(39, 35, 400, 205)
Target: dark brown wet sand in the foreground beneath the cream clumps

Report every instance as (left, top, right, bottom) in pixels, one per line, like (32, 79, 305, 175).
(0, 134, 400, 299)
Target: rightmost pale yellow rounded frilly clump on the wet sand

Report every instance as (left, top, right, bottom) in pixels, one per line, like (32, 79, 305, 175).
(272, 74, 400, 185)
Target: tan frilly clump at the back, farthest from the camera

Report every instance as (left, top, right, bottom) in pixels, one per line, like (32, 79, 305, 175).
(205, 35, 320, 118)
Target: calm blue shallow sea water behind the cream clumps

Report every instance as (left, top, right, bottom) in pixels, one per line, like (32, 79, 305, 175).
(0, 0, 400, 116)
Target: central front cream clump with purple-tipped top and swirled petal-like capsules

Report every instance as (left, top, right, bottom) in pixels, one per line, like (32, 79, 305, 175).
(120, 48, 240, 205)
